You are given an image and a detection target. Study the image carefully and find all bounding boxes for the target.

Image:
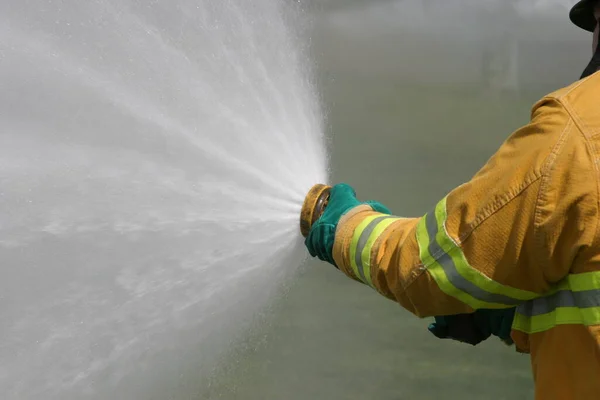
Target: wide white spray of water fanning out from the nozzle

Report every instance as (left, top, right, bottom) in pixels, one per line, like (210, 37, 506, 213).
(0, 0, 328, 400)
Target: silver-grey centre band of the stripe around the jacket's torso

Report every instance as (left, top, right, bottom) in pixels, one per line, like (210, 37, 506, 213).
(517, 289, 600, 317)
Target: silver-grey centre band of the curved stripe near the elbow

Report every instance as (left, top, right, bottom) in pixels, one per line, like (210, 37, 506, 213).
(425, 211, 523, 306)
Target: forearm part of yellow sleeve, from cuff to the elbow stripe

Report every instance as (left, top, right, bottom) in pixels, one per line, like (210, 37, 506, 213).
(333, 211, 478, 317)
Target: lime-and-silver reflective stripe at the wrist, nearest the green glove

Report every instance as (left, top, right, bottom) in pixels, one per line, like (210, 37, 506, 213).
(350, 215, 398, 286)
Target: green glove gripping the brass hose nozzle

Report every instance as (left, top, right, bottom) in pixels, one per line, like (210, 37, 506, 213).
(304, 183, 390, 268)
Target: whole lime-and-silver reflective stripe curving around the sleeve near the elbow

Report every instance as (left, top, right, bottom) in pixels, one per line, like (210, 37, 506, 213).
(417, 198, 539, 309)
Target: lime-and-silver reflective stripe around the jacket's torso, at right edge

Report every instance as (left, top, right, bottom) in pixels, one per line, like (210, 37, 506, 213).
(513, 272, 600, 333)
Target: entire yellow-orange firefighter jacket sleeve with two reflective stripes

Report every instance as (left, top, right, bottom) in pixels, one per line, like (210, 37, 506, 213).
(333, 97, 598, 317)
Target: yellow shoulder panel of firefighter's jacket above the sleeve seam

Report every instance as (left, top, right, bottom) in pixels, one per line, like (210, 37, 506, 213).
(532, 72, 600, 137)
